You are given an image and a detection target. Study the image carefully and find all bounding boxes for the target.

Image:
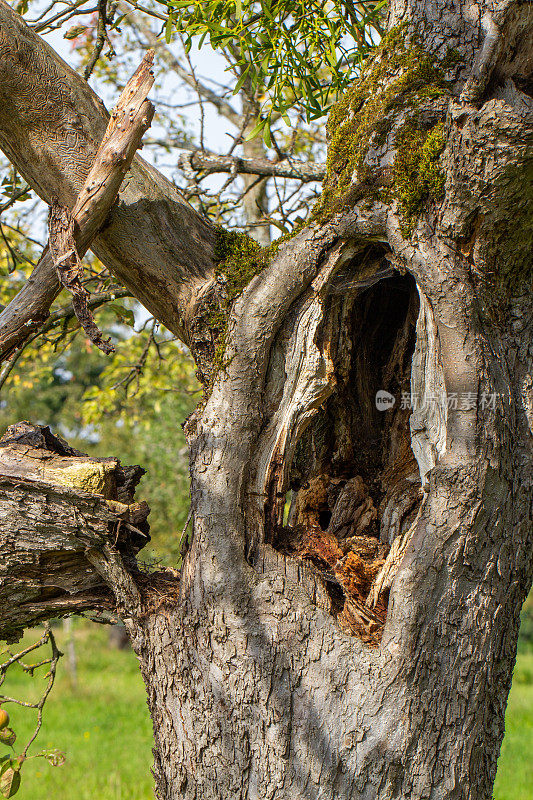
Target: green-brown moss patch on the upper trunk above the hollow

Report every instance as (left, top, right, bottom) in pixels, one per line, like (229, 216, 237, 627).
(314, 24, 459, 221)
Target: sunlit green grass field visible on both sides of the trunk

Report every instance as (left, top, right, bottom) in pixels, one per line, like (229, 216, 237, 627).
(2, 623, 533, 800)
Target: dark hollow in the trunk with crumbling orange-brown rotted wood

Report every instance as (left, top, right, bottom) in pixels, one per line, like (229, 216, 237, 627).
(271, 275, 422, 644)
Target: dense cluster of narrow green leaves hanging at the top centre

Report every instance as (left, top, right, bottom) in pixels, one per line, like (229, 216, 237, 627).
(170, 0, 385, 123)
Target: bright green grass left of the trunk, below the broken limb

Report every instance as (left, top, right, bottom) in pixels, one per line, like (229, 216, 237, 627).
(0, 623, 153, 800)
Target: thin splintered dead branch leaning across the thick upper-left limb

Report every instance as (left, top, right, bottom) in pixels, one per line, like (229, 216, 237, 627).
(0, 51, 154, 360)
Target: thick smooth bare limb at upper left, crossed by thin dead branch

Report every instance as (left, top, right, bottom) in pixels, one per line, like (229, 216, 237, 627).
(0, 0, 216, 335)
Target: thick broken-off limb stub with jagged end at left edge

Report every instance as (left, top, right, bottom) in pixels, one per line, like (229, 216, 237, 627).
(0, 423, 150, 640)
